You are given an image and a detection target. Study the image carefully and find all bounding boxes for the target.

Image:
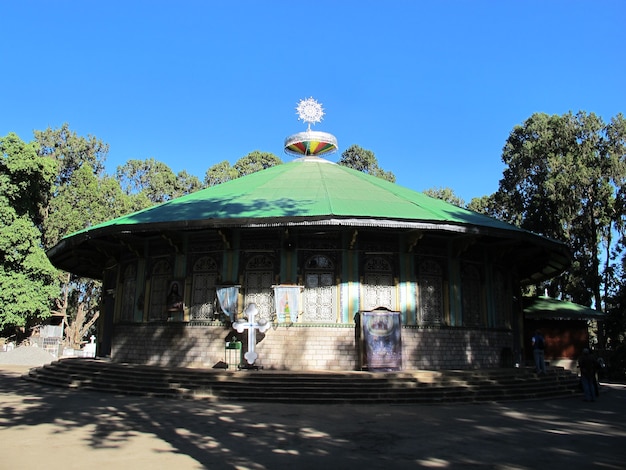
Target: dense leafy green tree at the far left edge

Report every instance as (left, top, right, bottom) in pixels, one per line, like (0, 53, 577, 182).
(0, 133, 59, 331)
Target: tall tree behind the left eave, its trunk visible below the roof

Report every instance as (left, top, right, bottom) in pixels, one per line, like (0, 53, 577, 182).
(34, 124, 131, 347)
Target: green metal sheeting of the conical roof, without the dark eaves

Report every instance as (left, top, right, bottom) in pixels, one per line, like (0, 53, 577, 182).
(71, 157, 524, 236)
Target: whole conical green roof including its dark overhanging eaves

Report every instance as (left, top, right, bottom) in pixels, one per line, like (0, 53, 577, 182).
(47, 157, 570, 283)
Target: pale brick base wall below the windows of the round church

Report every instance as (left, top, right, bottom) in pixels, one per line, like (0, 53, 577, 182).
(111, 322, 513, 371)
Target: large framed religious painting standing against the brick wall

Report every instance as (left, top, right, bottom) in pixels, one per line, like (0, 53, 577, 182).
(360, 310, 402, 370)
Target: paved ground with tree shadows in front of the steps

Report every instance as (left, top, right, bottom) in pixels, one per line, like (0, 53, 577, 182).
(0, 365, 626, 470)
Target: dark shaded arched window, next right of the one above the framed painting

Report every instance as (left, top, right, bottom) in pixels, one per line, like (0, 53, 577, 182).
(417, 258, 443, 325)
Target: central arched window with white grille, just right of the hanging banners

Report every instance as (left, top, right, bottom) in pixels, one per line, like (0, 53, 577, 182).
(302, 255, 337, 322)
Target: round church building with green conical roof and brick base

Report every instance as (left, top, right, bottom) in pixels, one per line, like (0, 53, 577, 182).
(48, 102, 570, 371)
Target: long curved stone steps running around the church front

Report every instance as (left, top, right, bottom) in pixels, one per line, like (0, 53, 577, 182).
(24, 358, 579, 404)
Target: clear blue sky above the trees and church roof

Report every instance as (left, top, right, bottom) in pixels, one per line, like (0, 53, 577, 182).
(0, 0, 626, 202)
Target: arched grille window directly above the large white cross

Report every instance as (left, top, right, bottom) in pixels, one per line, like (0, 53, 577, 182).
(243, 255, 274, 321)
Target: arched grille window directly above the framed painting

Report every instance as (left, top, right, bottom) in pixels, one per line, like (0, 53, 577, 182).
(361, 256, 396, 311)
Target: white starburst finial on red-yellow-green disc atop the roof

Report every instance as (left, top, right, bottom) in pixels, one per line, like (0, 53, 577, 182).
(285, 97, 337, 157)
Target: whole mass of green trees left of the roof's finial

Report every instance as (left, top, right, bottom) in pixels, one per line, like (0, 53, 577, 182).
(0, 124, 282, 338)
